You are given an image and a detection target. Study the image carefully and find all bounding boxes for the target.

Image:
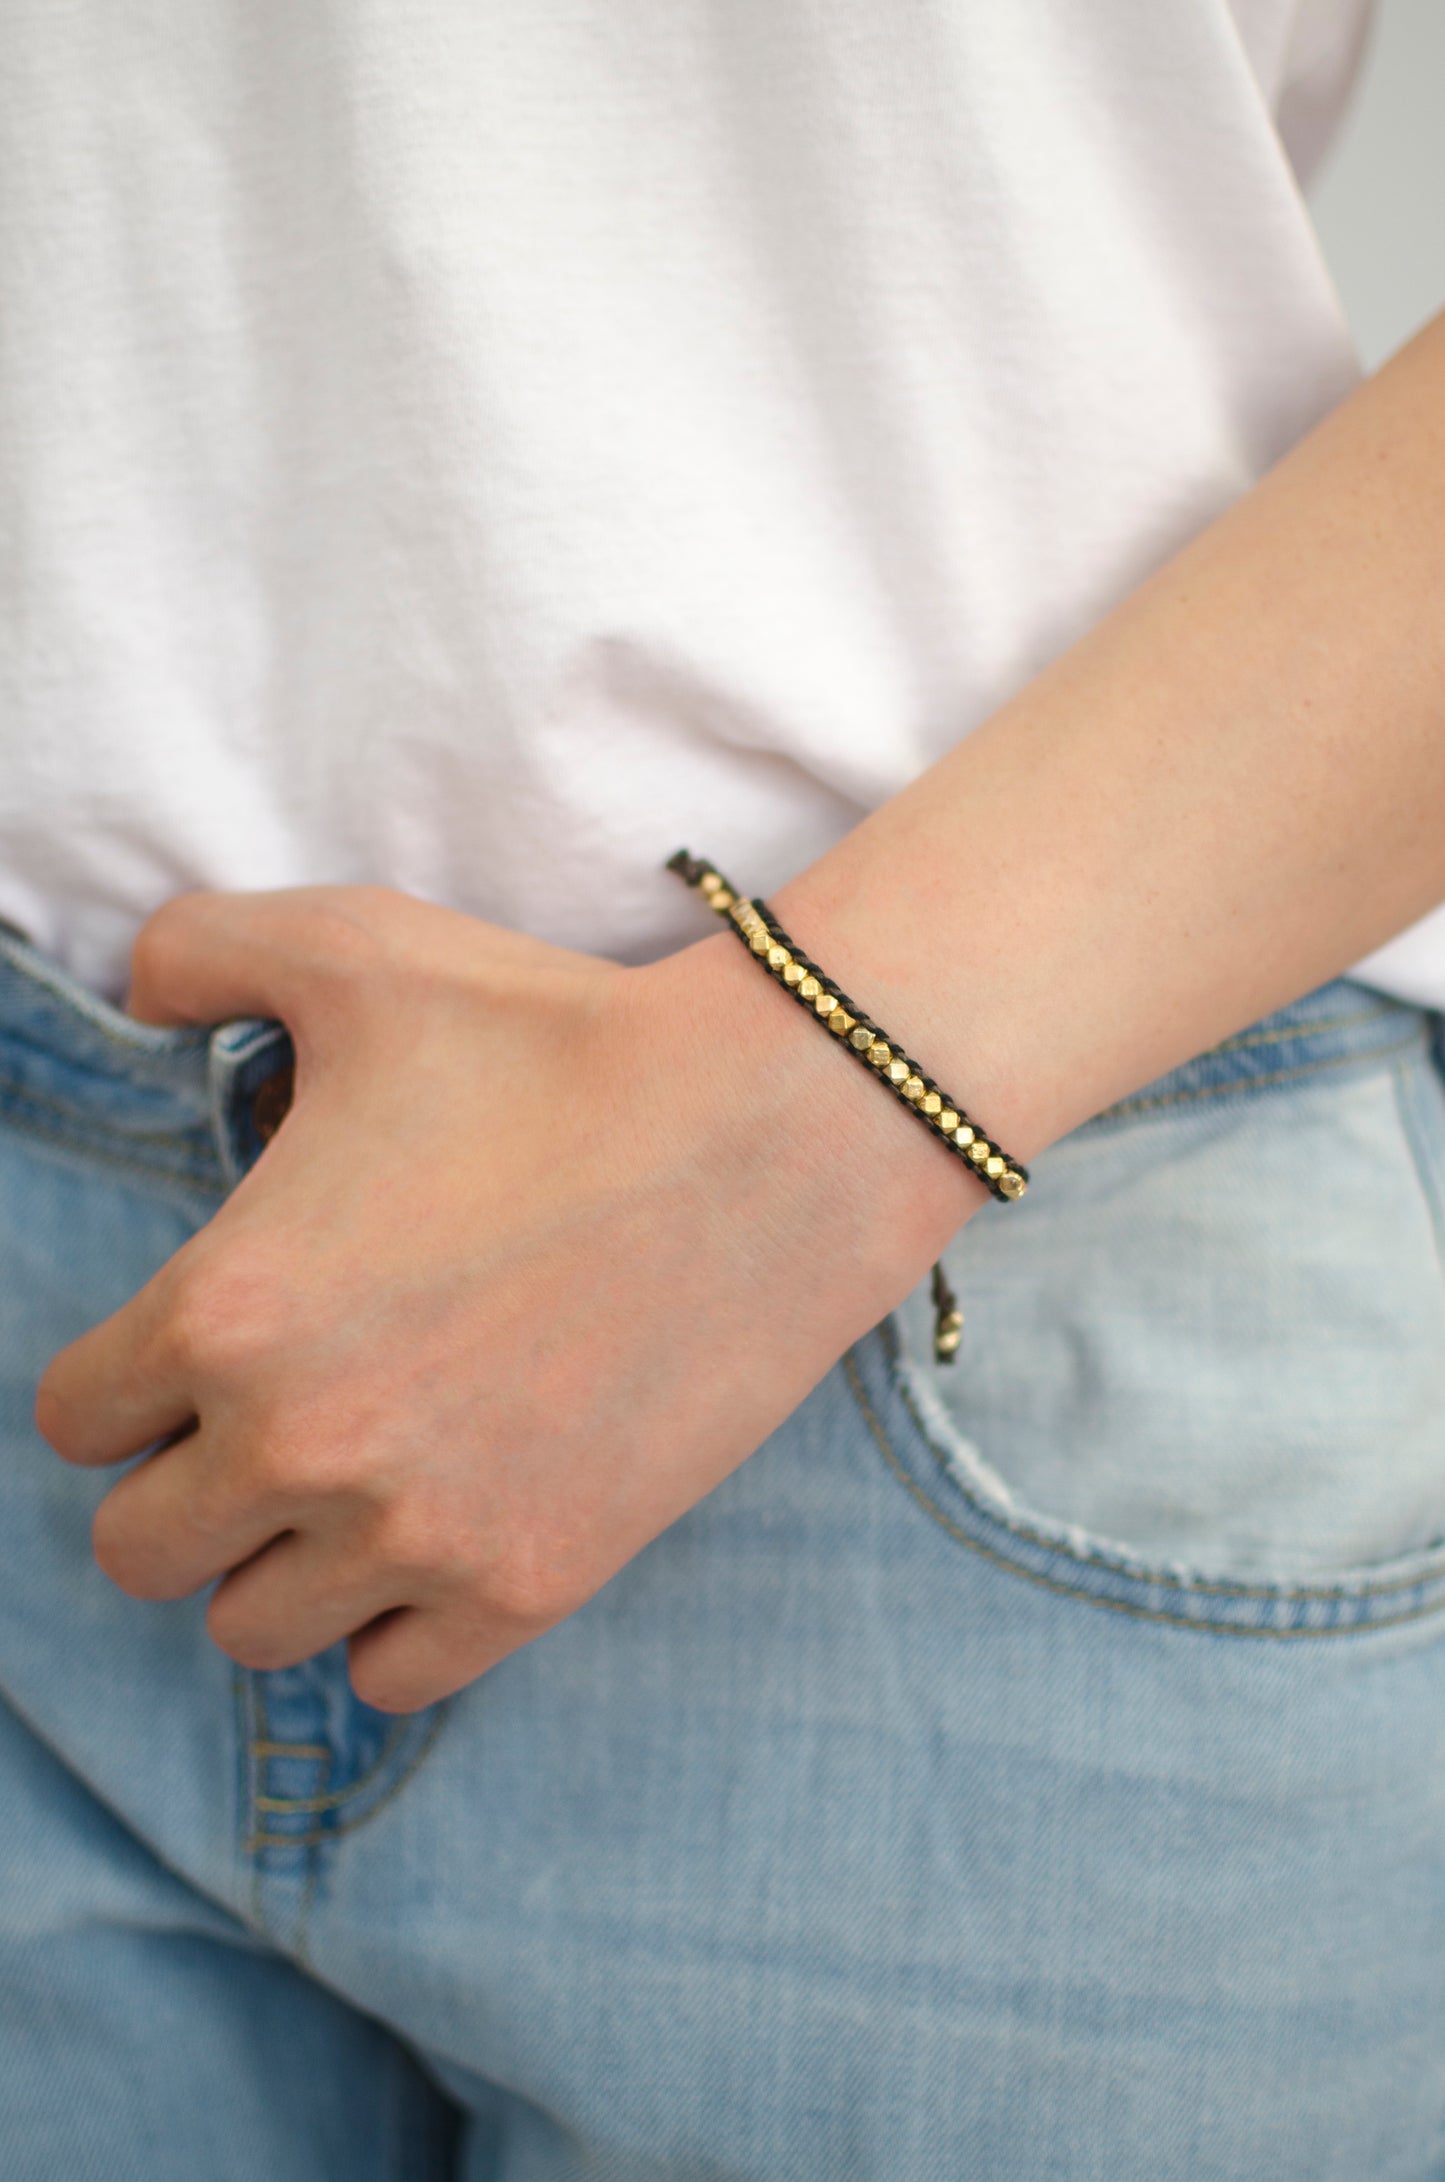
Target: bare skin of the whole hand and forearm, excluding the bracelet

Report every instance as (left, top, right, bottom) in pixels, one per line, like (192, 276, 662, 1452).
(35, 316, 1445, 1711)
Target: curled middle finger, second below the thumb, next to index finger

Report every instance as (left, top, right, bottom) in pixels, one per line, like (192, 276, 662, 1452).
(92, 1429, 292, 1599)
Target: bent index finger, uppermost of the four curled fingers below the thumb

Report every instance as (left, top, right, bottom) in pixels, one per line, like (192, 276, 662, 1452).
(35, 1246, 196, 1466)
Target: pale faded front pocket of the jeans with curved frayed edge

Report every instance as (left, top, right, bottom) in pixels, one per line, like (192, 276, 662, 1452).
(853, 1004, 1445, 1621)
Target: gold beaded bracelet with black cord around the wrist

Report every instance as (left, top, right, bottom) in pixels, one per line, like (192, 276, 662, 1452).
(666, 849, 1028, 1364)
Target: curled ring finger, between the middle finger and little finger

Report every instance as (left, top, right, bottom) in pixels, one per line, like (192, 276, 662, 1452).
(205, 1532, 410, 1674)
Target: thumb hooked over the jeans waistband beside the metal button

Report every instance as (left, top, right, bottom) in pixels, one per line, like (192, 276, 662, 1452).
(127, 886, 375, 1023)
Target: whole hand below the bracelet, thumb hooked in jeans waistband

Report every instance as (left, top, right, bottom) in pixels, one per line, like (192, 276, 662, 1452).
(35, 888, 982, 1711)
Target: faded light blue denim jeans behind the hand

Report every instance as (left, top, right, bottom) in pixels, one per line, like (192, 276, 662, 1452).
(0, 920, 1445, 2182)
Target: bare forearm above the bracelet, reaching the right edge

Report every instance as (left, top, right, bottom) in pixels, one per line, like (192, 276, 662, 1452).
(759, 303, 1445, 1211)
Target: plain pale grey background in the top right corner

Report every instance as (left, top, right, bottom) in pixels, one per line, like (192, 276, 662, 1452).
(1310, 0, 1445, 371)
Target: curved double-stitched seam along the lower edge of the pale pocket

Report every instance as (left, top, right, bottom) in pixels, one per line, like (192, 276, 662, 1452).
(843, 1351, 1445, 1639)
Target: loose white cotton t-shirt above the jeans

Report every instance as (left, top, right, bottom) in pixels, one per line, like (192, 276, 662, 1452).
(0, 0, 1445, 1002)
